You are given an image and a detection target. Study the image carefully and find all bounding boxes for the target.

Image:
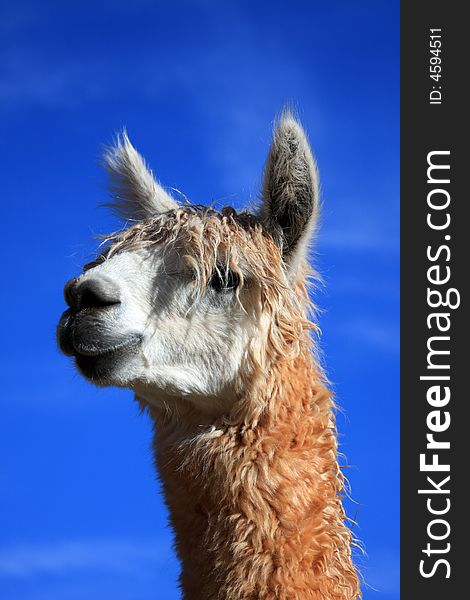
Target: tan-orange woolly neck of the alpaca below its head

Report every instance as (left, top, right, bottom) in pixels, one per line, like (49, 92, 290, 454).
(148, 353, 360, 600)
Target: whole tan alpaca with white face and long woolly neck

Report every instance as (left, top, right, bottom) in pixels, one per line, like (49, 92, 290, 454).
(58, 113, 360, 600)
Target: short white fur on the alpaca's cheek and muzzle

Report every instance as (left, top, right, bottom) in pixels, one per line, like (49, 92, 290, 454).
(76, 245, 255, 412)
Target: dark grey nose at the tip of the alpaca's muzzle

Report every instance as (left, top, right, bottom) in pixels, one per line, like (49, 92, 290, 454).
(64, 277, 121, 312)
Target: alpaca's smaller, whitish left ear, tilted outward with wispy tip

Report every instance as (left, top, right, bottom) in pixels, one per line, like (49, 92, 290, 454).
(103, 131, 178, 220)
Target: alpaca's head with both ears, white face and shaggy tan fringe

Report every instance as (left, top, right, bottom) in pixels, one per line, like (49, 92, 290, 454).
(58, 115, 318, 412)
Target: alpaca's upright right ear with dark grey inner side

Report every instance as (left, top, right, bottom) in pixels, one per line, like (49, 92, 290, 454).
(261, 113, 319, 273)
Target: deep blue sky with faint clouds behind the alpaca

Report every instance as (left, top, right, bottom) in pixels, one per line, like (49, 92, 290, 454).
(0, 0, 399, 600)
